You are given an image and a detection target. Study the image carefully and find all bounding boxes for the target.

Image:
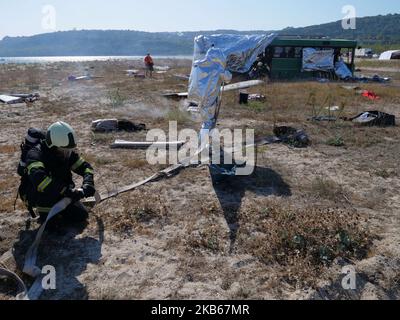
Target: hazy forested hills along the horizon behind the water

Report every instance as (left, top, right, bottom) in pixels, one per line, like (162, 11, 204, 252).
(0, 14, 400, 57)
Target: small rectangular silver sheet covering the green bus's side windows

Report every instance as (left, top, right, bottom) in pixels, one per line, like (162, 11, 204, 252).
(302, 48, 335, 71)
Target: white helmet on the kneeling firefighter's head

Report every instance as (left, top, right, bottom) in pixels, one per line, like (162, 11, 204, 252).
(46, 121, 77, 149)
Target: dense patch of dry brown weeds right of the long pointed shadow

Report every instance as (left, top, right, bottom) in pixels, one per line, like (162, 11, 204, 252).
(238, 204, 373, 285)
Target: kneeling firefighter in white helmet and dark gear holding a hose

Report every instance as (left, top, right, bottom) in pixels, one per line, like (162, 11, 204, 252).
(26, 121, 96, 226)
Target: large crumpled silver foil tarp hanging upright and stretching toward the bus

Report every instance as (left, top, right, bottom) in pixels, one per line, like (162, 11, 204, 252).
(188, 34, 276, 175)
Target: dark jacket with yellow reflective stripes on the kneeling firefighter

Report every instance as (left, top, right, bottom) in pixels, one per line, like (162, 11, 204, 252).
(26, 141, 94, 213)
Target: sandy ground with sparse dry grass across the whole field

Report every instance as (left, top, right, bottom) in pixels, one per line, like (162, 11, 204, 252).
(0, 60, 400, 299)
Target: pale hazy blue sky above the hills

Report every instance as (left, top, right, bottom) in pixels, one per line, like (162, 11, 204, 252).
(0, 0, 400, 39)
